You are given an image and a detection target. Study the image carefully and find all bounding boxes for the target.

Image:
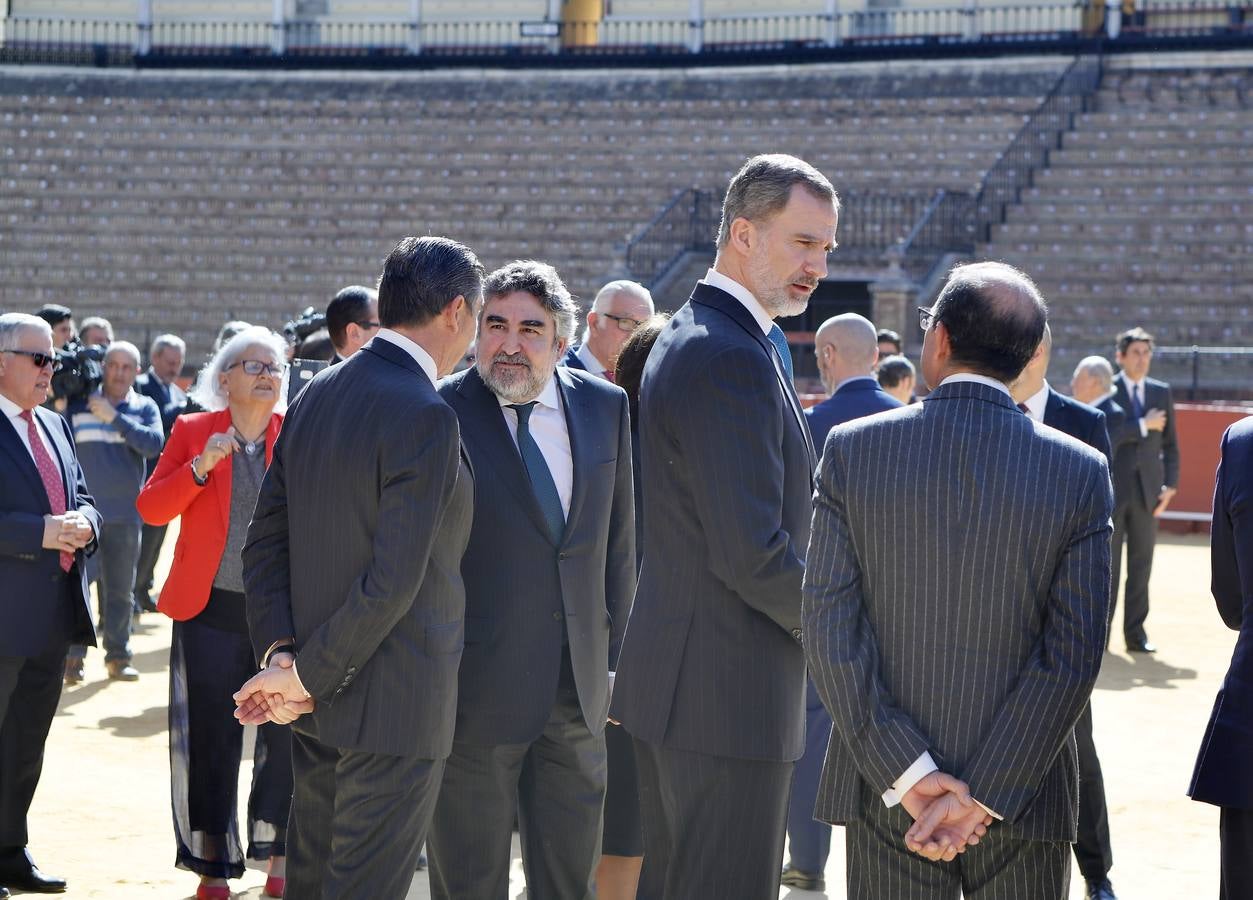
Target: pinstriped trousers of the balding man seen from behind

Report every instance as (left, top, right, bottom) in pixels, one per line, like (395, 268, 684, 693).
(845, 787, 1070, 900)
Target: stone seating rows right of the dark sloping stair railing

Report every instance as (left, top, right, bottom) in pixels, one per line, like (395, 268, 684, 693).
(979, 54, 1253, 396)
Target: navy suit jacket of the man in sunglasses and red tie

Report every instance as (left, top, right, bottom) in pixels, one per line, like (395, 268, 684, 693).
(0, 406, 100, 657)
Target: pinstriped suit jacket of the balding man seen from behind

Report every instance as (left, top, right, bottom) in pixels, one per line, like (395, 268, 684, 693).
(804, 382, 1113, 841)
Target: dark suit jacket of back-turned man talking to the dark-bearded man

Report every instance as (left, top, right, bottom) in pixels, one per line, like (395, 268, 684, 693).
(243, 340, 474, 760)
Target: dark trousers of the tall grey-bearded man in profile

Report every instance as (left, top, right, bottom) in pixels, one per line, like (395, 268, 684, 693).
(635, 738, 791, 900)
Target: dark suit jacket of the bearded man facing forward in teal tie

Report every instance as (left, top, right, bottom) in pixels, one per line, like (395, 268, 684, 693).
(440, 366, 635, 745)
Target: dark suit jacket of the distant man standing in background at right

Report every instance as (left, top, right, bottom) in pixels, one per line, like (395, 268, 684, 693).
(1113, 372, 1179, 509)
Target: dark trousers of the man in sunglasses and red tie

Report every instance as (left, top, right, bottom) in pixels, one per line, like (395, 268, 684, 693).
(0, 642, 66, 852)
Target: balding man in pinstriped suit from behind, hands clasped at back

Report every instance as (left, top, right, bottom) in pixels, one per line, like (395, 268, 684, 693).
(804, 263, 1113, 900)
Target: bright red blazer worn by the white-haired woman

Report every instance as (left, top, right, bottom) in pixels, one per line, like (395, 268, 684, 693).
(135, 410, 283, 620)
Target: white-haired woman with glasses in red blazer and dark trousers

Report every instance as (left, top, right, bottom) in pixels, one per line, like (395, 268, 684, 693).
(135, 327, 292, 900)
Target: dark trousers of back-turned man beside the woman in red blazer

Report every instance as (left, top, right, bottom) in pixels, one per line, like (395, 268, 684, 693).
(287, 732, 444, 900)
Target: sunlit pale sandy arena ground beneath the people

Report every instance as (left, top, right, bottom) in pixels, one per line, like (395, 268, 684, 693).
(30, 533, 1234, 900)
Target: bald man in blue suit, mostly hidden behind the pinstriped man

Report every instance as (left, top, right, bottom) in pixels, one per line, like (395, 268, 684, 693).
(782, 312, 902, 891)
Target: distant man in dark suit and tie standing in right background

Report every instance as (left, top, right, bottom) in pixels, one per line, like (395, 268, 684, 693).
(1110, 328, 1179, 653)
